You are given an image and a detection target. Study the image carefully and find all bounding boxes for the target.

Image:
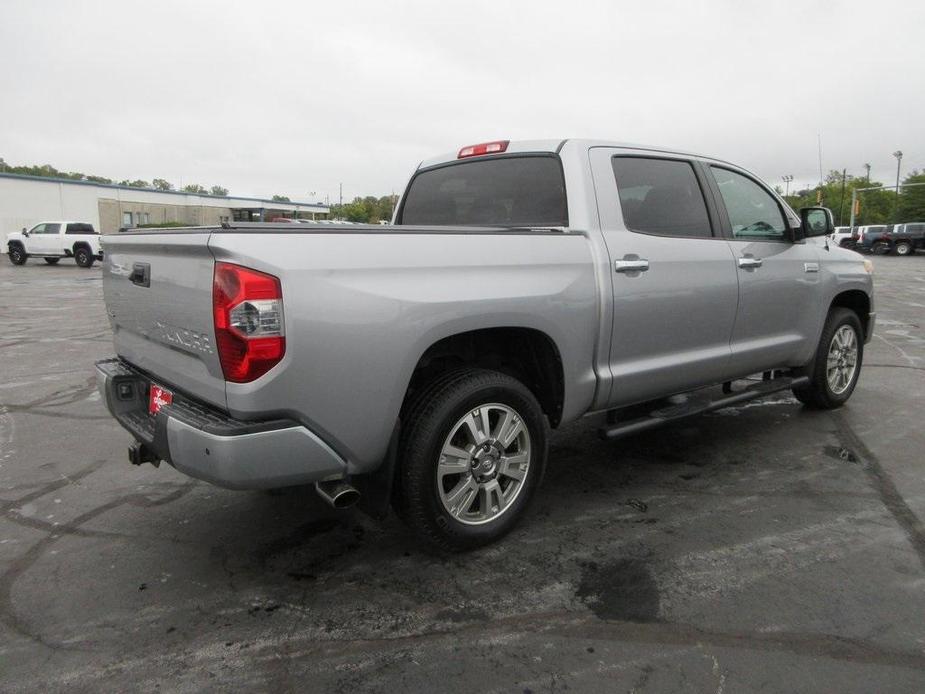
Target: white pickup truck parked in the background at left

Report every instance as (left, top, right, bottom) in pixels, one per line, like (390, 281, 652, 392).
(6, 221, 103, 267)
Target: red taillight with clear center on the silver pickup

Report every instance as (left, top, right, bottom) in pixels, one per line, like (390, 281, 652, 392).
(212, 263, 286, 383)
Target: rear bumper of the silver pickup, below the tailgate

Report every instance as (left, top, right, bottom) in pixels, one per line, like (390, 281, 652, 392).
(96, 359, 347, 489)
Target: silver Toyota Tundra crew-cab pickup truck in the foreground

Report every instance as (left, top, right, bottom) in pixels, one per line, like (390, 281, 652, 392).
(97, 140, 875, 549)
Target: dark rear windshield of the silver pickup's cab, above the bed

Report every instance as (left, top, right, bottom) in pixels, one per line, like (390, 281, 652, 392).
(397, 156, 568, 227)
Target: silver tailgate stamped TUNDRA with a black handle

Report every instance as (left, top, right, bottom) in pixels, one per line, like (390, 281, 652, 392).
(103, 230, 225, 408)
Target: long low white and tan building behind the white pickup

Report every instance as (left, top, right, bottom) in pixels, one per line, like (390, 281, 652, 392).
(0, 173, 329, 239)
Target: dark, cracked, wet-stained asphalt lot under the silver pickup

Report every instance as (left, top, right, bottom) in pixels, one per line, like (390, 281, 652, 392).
(0, 256, 925, 693)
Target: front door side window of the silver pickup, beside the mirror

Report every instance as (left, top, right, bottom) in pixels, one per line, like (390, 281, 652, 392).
(710, 166, 787, 239)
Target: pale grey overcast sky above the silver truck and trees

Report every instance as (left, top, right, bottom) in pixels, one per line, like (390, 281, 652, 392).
(0, 0, 925, 202)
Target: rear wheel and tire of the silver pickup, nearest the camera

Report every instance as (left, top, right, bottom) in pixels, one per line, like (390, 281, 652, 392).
(398, 369, 547, 551)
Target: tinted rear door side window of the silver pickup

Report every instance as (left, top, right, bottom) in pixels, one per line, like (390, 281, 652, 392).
(613, 157, 713, 238)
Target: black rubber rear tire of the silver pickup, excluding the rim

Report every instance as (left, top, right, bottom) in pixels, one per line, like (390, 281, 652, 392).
(396, 369, 548, 551)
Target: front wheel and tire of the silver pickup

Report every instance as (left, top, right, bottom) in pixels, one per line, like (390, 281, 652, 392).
(793, 308, 864, 410)
